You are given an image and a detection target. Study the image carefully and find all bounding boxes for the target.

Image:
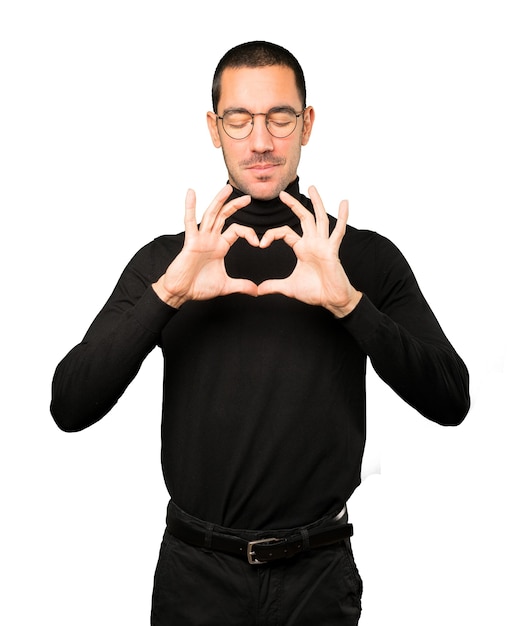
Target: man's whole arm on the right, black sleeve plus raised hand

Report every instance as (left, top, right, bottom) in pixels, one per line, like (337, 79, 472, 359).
(259, 188, 469, 425)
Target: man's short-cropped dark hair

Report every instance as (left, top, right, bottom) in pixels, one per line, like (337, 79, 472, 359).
(212, 41, 307, 112)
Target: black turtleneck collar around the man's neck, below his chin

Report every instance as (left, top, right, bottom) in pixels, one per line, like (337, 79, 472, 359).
(226, 178, 312, 231)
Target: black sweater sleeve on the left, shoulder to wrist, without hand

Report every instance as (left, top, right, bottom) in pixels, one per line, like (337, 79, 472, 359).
(50, 236, 179, 432)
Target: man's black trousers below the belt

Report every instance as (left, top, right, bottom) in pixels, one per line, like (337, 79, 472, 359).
(151, 504, 362, 626)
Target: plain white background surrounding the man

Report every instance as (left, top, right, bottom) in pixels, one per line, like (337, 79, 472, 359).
(0, 0, 517, 626)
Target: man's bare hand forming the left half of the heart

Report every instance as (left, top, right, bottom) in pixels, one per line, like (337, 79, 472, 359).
(153, 185, 259, 308)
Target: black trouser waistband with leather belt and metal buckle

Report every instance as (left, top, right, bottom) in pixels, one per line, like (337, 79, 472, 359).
(167, 500, 353, 565)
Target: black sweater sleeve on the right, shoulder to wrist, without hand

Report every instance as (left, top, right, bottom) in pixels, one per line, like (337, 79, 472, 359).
(342, 229, 470, 425)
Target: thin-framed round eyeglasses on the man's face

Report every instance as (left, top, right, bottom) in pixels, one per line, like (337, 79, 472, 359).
(217, 107, 305, 139)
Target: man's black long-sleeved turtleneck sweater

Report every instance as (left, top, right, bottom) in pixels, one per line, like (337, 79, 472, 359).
(51, 181, 469, 529)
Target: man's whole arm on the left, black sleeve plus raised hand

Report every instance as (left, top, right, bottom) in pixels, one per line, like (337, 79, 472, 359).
(51, 185, 258, 431)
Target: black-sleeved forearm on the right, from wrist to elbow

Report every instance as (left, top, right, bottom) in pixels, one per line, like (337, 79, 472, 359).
(342, 296, 470, 425)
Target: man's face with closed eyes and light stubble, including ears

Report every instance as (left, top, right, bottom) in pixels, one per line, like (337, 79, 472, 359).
(207, 65, 314, 200)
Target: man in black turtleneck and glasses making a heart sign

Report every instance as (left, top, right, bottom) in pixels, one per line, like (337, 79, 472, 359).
(51, 42, 469, 626)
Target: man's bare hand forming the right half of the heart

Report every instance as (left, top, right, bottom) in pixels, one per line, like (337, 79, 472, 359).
(258, 187, 362, 317)
